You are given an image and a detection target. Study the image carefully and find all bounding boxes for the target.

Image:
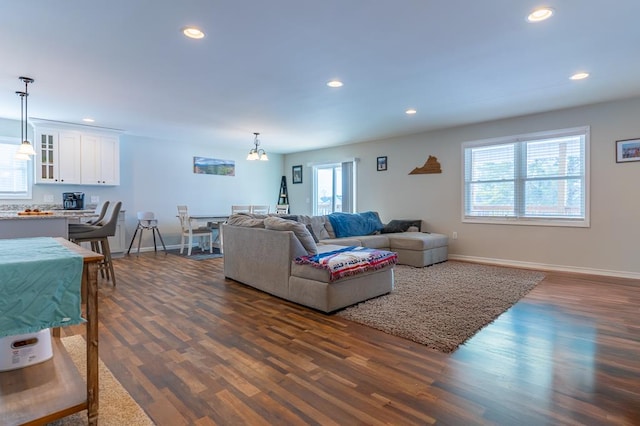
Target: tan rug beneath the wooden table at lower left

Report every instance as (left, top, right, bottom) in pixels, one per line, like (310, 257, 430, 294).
(49, 335, 154, 426)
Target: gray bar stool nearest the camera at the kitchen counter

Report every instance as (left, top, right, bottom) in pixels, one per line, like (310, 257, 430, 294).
(69, 201, 122, 287)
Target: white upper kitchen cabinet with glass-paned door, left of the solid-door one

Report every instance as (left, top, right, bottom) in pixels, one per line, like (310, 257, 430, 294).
(35, 129, 81, 184)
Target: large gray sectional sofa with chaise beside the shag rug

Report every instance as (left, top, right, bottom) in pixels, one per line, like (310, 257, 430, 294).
(222, 214, 447, 312)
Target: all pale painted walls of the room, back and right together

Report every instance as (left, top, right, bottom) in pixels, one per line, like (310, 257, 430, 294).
(0, 94, 640, 278)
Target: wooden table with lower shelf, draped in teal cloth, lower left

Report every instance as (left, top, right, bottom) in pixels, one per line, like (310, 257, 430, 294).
(0, 238, 103, 425)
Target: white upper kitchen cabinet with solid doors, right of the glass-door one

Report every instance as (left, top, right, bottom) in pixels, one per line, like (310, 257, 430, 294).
(81, 133, 120, 185)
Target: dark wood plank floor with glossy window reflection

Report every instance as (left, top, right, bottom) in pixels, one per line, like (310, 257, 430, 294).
(67, 253, 640, 426)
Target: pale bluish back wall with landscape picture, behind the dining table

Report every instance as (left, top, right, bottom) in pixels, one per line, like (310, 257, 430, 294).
(0, 118, 283, 247)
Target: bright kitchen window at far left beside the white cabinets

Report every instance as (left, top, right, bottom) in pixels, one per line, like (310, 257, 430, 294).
(0, 139, 32, 200)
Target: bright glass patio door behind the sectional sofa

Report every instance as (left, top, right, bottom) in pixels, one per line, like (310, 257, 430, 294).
(313, 161, 355, 216)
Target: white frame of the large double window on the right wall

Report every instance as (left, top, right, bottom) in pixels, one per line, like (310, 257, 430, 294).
(461, 126, 590, 228)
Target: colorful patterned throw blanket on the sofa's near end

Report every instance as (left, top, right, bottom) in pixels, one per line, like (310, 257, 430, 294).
(295, 246, 398, 281)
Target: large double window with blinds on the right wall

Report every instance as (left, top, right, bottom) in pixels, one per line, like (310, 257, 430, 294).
(462, 127, 589, 227)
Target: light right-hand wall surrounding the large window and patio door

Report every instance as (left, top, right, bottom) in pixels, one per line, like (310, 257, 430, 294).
(284, 98, 640, 278)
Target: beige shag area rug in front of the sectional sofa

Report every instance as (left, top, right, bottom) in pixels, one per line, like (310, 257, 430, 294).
(337, 261, 544, 353)
